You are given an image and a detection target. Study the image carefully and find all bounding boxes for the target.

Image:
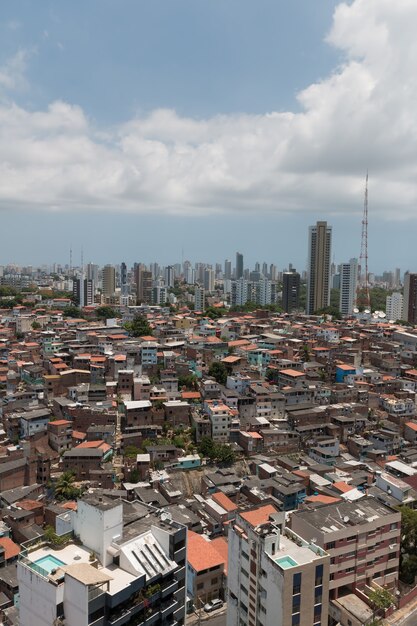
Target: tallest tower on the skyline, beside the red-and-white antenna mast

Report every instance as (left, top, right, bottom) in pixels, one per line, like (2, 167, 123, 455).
(306, 222, 332, 315)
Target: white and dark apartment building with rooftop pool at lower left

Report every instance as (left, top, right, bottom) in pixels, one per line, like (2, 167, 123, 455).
(17, 494, 187, 626)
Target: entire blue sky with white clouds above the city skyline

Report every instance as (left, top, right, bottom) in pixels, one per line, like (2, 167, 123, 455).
(0, 0, 417, 273)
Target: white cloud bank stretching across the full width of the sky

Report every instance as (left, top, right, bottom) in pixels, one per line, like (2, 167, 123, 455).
(0, 0, 417, 219)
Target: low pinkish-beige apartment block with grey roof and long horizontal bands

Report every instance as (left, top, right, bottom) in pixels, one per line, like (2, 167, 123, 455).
(291, 496, 401, 599)
